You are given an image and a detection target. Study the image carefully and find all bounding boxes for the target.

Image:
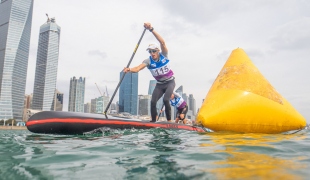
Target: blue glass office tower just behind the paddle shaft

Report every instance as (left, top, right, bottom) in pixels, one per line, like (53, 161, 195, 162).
(119, 71, 138, 115)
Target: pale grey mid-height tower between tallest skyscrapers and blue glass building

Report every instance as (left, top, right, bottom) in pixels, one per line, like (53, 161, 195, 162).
(68, 77, 85, 112)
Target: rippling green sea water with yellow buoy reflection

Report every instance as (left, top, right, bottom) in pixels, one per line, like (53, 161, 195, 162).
(0, 129, 310, 180)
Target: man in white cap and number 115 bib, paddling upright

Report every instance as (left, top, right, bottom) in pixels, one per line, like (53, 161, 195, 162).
(124, 23, 175, 122)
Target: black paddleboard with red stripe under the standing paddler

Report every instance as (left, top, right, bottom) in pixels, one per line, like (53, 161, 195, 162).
(26, 111, 206, 134)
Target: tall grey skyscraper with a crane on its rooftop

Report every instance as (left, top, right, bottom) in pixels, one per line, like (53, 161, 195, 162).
(32, 18, 60, 111)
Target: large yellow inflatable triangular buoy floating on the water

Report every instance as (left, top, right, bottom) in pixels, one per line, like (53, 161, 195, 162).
(196, 48, 306, 133)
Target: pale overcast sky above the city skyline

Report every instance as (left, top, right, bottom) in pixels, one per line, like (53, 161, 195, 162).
(26, 0, 310, 123)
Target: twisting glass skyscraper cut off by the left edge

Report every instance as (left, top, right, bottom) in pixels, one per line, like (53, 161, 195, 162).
(0, 0, 33, 121)
